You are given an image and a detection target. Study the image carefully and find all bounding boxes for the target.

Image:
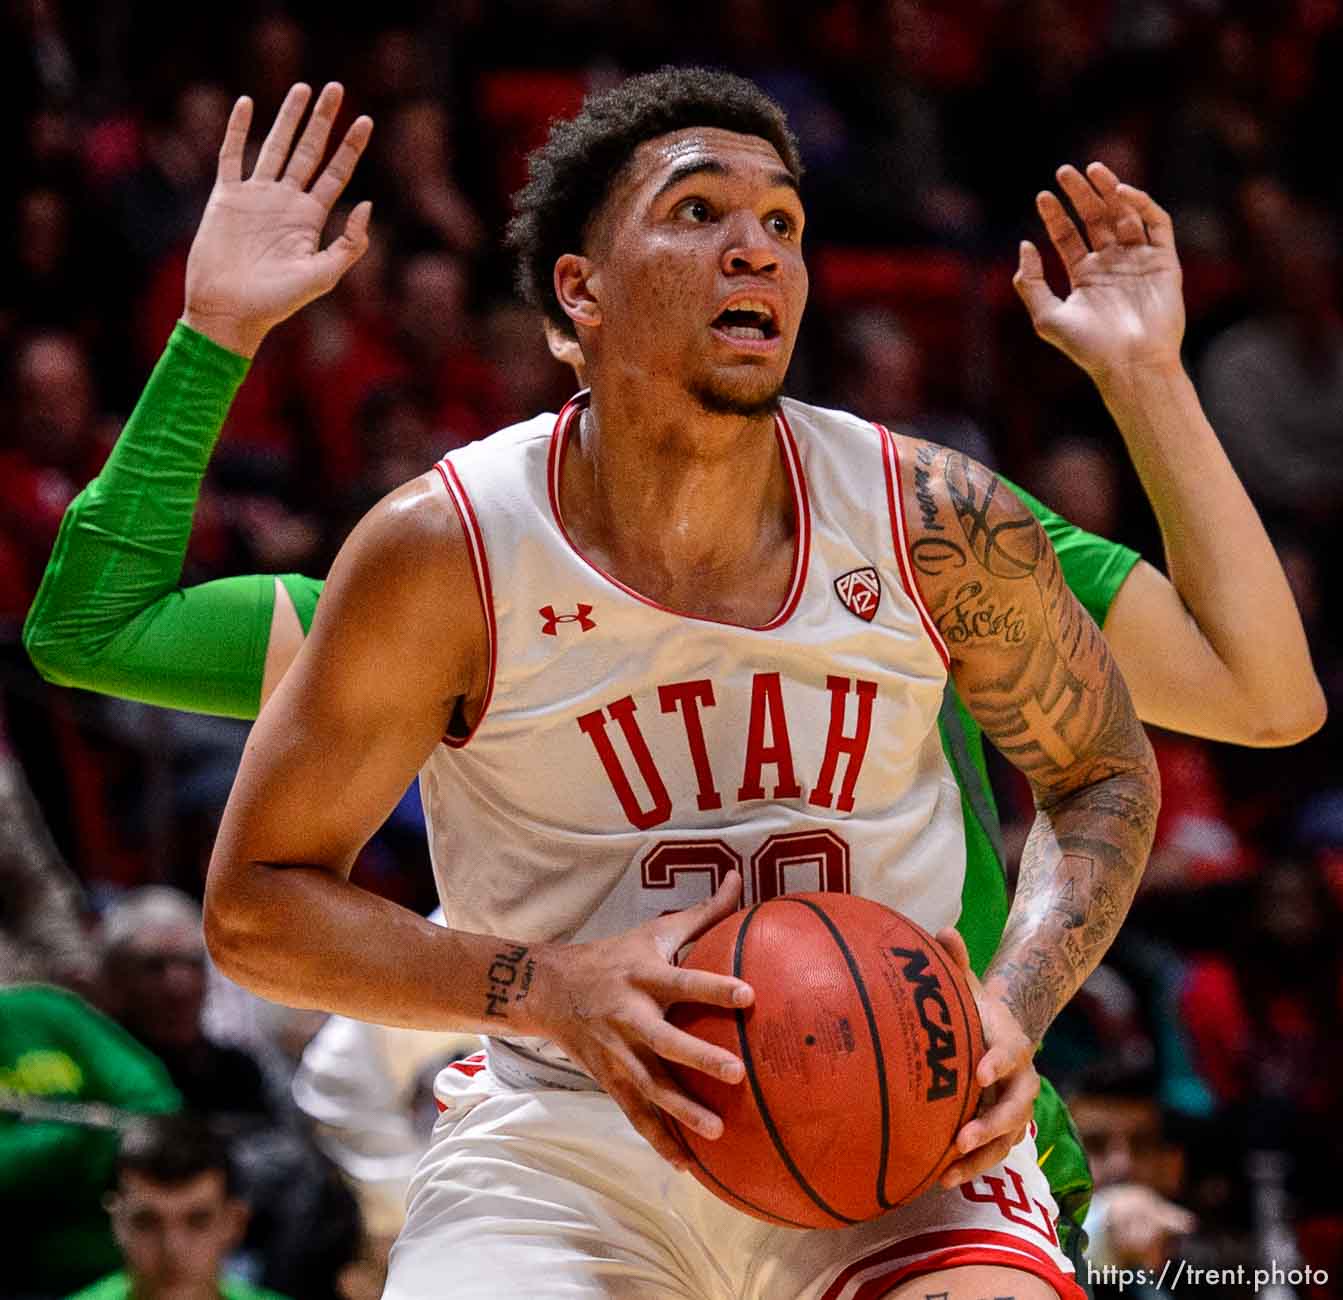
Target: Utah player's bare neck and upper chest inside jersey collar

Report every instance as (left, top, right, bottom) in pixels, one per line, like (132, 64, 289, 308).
(561, 393, 795, 595)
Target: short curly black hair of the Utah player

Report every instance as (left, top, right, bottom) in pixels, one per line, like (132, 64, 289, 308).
(506, 67, 802, 334)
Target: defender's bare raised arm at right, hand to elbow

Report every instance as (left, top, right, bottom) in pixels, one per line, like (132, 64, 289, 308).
(1014, 163, 1326, 745)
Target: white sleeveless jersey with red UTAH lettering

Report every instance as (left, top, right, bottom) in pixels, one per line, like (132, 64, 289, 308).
(422, 393, 964, 983)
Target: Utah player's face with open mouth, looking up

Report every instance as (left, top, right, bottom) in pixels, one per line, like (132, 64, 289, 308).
(590, 128, 807, 415)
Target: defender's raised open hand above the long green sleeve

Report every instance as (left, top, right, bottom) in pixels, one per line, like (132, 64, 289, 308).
(183, 82, 373, 357)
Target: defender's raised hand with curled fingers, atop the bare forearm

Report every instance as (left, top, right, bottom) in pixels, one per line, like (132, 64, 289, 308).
(1013, 163, 1185, 380)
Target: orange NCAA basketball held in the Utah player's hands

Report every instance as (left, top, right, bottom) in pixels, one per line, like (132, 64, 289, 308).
(669, 893, 984, 1227)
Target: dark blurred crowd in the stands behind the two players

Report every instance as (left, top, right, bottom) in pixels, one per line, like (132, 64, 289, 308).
(0, 0, 1343, 1297)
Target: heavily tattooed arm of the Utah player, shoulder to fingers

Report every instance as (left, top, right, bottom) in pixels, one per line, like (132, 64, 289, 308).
(897, 438, 1159, 1183)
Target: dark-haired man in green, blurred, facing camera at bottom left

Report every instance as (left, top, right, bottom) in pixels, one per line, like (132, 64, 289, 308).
(73, 1116, 291, 1300)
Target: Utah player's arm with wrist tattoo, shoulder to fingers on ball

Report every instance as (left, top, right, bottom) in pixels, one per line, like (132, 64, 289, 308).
(205, 475, 749, 1164)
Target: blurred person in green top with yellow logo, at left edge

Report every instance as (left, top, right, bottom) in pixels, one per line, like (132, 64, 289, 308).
(0, 984, 180, 1296)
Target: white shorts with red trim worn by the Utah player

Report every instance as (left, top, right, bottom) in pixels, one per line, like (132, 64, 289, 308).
(384, 1045, 1085, 1300)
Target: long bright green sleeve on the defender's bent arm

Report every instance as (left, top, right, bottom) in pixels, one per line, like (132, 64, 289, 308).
(23, 324, 316, 718)
